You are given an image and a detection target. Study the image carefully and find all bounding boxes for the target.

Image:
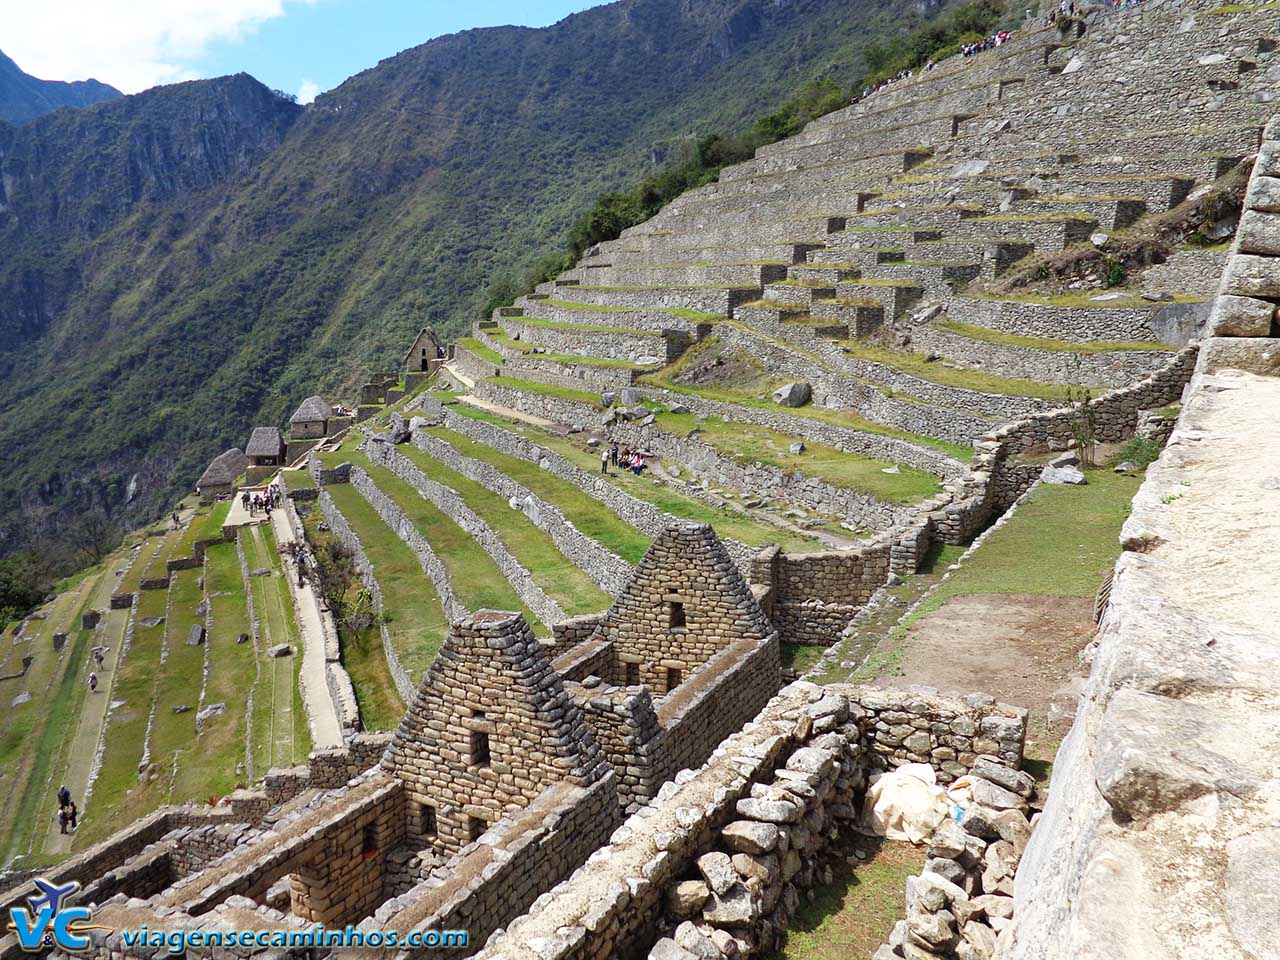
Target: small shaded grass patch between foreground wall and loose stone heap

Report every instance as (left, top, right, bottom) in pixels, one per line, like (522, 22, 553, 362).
(774, 838, 925, 960)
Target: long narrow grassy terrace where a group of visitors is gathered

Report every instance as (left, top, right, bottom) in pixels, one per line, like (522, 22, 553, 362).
(451, 403, 827, 553)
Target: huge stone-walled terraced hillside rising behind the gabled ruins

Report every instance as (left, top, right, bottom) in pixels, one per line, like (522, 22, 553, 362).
(373, 0, 1276, 675)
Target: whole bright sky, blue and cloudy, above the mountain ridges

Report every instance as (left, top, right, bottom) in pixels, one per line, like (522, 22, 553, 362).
(0, 0, 600, 100)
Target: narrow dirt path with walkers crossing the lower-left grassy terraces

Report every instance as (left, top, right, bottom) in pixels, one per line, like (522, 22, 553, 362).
(44, 542, 163, 856)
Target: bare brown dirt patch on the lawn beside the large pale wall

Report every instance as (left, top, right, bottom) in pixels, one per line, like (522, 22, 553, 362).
(876, 594, 1094, 760)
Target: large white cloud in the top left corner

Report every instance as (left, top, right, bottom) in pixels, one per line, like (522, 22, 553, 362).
(3, 0, 315, 93)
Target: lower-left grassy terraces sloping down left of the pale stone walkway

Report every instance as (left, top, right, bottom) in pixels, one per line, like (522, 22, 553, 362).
(0, 500, 311, 869)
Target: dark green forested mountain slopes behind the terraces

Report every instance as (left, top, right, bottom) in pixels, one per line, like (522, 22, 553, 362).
(0, 0, 952, 560)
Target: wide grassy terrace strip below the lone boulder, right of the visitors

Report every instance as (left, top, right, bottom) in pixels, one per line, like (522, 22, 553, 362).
(658, 413, 941, 503)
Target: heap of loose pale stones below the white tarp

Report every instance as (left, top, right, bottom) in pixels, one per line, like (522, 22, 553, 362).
(872, 758, 1036, 960)
